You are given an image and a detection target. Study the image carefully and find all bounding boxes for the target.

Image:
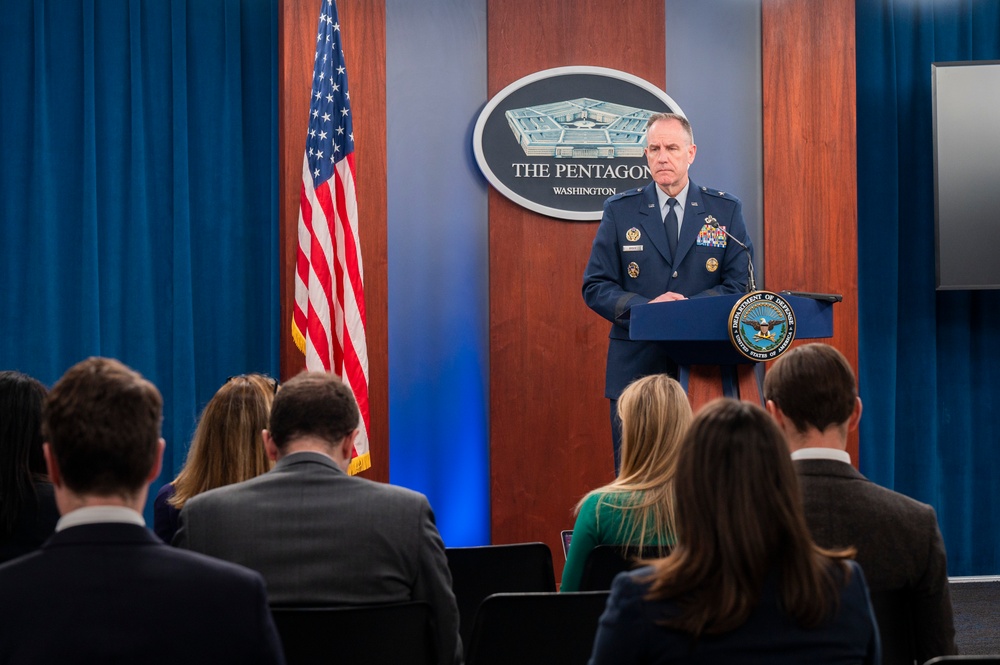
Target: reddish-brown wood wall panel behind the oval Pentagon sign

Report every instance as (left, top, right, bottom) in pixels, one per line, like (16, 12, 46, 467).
(487, 0, 666, 578)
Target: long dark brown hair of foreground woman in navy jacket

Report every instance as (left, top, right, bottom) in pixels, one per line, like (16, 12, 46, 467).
(653, 399, 839, 634)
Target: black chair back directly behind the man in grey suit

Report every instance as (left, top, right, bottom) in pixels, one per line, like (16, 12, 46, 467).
(271, 601, 436, 665)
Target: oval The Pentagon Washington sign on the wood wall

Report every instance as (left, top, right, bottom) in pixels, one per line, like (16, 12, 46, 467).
(472, 67, 684, 221)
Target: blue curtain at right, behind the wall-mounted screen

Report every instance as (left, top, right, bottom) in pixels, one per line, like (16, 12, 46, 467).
(856, 0, 1000, 575)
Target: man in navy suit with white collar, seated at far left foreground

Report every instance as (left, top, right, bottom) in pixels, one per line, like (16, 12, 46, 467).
(0, 358, 284, 665)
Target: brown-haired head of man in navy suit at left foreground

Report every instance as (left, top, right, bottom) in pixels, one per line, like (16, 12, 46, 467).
(42, 358, 163, 497)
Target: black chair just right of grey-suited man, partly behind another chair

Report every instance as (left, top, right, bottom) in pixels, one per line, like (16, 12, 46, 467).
(445, 543, 556, 647)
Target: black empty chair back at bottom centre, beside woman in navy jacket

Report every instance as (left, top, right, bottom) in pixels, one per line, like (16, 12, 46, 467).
(465, 591, 608, 665)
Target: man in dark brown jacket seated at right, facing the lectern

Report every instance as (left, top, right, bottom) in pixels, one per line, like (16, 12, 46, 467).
(764, 344, 956, 665)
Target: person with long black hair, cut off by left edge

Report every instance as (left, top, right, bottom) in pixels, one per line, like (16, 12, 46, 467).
(0, 371, 59, 562)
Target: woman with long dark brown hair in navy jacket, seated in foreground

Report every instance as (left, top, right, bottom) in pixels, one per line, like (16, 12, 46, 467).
(590, 400, 881, 665)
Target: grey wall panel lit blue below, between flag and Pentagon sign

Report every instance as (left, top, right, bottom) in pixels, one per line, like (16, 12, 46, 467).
(384, 0, 490, 546)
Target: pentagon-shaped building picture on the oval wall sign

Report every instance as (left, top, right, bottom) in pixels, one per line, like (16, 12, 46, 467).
(504, 97, 653, 159)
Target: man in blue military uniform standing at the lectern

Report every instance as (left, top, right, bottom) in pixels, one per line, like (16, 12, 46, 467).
(583, 113, 752, 466)
